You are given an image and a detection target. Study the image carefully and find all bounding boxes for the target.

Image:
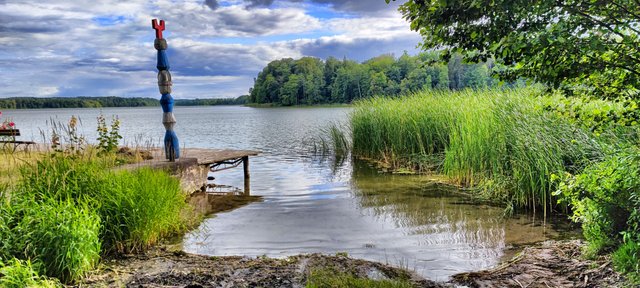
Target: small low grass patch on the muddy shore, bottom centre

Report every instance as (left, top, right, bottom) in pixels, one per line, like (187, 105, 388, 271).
(306, 269, 414, 288)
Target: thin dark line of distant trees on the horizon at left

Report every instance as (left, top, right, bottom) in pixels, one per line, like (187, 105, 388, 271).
(0, 95, 248, 109)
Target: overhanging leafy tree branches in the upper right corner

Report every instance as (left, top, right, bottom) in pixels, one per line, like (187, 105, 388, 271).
(386, 0, 640, 95)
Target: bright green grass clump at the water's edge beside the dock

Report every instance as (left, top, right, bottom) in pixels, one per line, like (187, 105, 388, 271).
(96, 168, 188, 252)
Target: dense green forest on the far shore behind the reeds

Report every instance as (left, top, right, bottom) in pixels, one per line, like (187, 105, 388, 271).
(249, 52, 510, 105)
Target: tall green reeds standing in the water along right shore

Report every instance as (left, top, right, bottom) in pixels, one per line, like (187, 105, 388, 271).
(351, 89, 602, 213)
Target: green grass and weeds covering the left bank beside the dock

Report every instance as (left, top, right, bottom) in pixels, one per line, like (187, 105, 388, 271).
(0, 118, 199, 287)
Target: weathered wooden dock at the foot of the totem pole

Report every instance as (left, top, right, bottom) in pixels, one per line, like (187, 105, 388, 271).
(122, 148, 260, 195)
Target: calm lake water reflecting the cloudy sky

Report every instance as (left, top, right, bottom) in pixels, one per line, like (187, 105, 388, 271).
(3, 106, 573, 280)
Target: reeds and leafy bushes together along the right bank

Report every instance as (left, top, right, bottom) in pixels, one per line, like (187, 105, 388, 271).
(350, 89, 640, 281)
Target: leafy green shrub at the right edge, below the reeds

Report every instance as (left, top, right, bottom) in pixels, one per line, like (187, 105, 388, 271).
(557, 148, 640, 253)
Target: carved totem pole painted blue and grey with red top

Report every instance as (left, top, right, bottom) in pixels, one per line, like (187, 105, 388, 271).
(151, 19, 180, 162)
